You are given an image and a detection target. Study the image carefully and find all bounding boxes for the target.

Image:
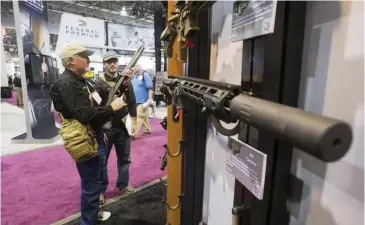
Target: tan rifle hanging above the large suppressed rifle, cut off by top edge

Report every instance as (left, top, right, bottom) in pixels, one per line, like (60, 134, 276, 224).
(160, 1, 215, 63)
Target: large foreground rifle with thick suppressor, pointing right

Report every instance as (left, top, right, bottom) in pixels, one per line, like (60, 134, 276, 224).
(160, 76, 352, 162)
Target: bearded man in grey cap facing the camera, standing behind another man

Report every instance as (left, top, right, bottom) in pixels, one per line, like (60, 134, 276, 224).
(96, 51, 137, 204)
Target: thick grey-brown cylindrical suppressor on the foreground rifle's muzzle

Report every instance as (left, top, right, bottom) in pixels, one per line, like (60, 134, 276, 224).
(230, 94, 352, 162)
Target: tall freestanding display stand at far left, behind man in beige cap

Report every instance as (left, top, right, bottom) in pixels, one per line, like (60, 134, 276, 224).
(12, 2, 58, 143)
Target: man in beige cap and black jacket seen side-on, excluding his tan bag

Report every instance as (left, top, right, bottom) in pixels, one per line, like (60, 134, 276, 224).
(51, 44, 132, 225)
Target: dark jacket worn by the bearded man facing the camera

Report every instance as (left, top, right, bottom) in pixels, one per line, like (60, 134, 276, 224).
(95, 72, 137, 128)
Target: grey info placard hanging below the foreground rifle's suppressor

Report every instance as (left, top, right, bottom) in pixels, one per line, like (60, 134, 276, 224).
(226, 137, 267, 200)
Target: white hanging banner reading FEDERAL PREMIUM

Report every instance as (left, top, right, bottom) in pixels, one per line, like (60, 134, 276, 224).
(56, 13, 105, 54)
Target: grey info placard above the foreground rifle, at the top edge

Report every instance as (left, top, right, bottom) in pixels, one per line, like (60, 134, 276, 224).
(231, 0, 277, 42)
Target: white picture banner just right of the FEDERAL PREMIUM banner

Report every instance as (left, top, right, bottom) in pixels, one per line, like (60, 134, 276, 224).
(108, 23, 155, 51)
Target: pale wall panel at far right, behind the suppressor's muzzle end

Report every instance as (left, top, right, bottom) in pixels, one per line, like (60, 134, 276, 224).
(288, 1, 364, 225)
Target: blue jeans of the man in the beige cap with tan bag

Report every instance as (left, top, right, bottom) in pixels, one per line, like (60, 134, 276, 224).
(76, 137, 105, 225)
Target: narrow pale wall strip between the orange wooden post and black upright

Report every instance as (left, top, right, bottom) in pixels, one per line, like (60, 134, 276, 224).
(202, 1, 242, 225)
